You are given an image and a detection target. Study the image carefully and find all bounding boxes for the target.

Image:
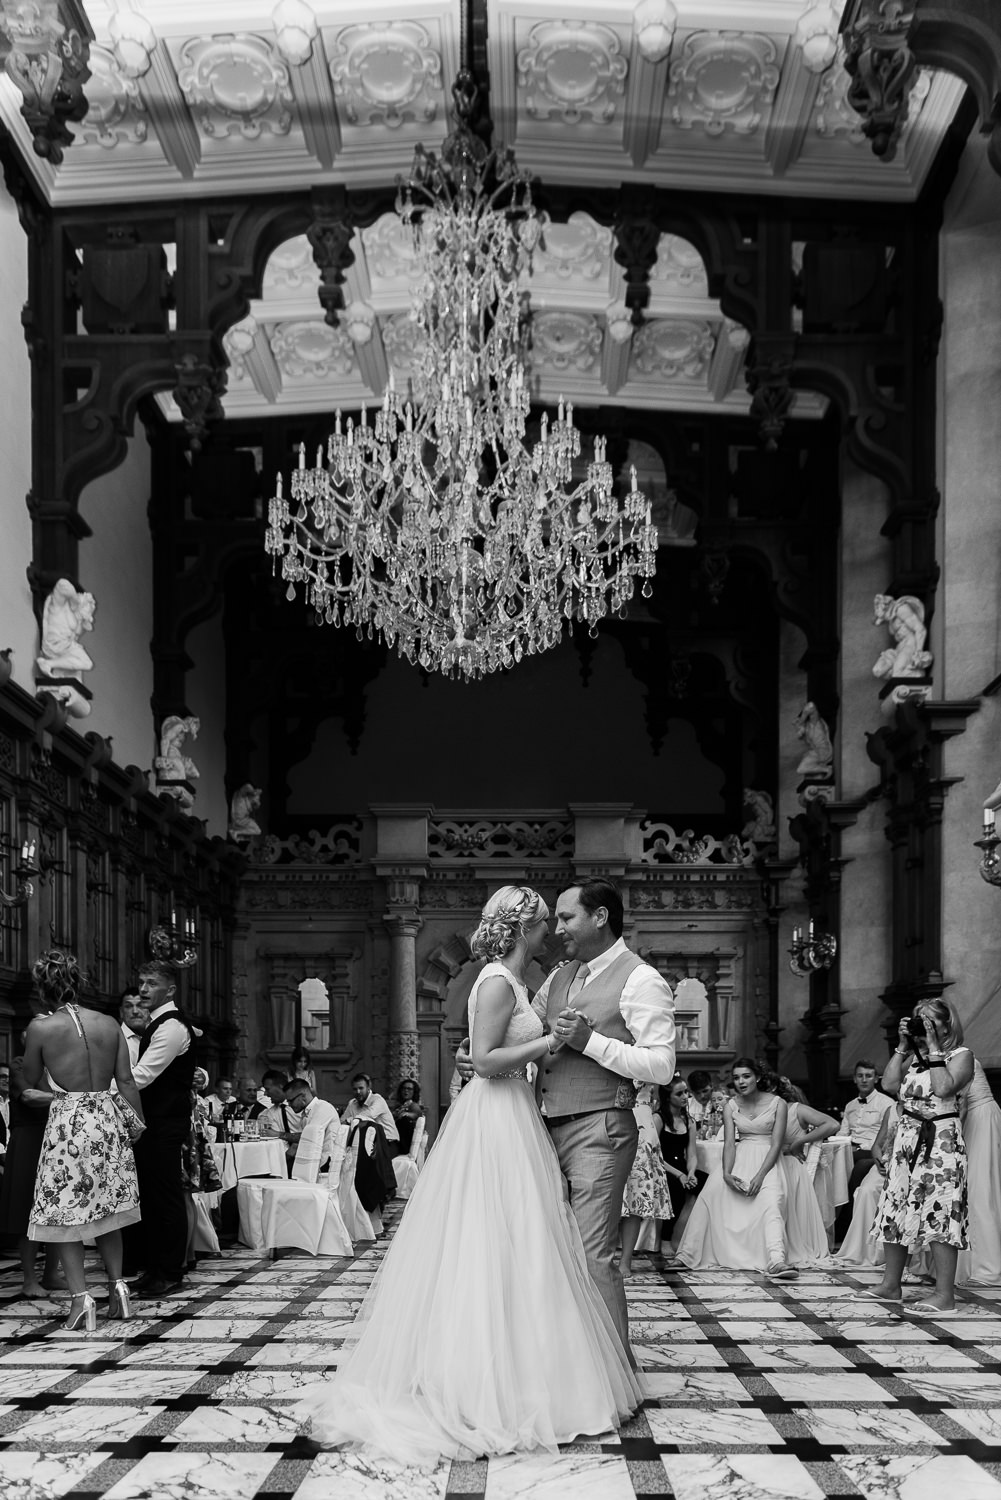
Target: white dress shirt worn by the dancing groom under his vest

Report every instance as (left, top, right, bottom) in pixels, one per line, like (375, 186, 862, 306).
(531, 938, 675, 1085)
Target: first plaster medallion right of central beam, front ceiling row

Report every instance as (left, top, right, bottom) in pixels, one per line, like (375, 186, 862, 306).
(518, 21, 629, 125)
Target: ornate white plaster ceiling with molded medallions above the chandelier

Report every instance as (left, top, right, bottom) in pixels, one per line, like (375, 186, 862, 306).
(0, 0, 963, 417)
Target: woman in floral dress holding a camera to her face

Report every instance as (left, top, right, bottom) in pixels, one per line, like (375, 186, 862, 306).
(863, 999, 972, 1317)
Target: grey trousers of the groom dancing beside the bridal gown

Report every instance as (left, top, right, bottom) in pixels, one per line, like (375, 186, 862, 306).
(549, 1110, 639, 1364)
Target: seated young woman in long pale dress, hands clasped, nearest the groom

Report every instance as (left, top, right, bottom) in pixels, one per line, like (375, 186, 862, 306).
(678, 1058, 795, 1281)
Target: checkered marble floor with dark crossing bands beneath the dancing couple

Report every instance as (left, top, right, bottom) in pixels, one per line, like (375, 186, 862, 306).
(0, 1215, 1001, 1500)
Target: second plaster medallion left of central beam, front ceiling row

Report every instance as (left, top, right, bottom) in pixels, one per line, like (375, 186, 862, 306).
(177, 33, 293, 141)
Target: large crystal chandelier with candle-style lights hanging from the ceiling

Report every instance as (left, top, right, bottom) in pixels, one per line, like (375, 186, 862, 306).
(266, 69, 657, 678)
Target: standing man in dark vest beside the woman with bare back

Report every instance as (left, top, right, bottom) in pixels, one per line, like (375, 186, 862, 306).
(132, 960, 195, 1298)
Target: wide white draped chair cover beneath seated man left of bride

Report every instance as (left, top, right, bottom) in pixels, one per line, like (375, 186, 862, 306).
(237, 1125, 353, 1256)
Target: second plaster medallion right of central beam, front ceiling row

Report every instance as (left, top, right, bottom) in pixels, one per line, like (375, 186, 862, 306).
(668, 32, 779, 135)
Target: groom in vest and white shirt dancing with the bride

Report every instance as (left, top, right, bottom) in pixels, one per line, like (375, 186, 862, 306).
(456, 879, 674, 1352)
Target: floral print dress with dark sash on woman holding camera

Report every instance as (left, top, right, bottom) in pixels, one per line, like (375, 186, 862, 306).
(869, 1053, 969, 1250)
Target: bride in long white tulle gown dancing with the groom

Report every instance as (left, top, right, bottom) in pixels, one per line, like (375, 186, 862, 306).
(299, 885, 642, 1464)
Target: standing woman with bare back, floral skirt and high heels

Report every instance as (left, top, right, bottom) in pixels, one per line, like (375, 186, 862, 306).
(24, 950, 143, 1332)
